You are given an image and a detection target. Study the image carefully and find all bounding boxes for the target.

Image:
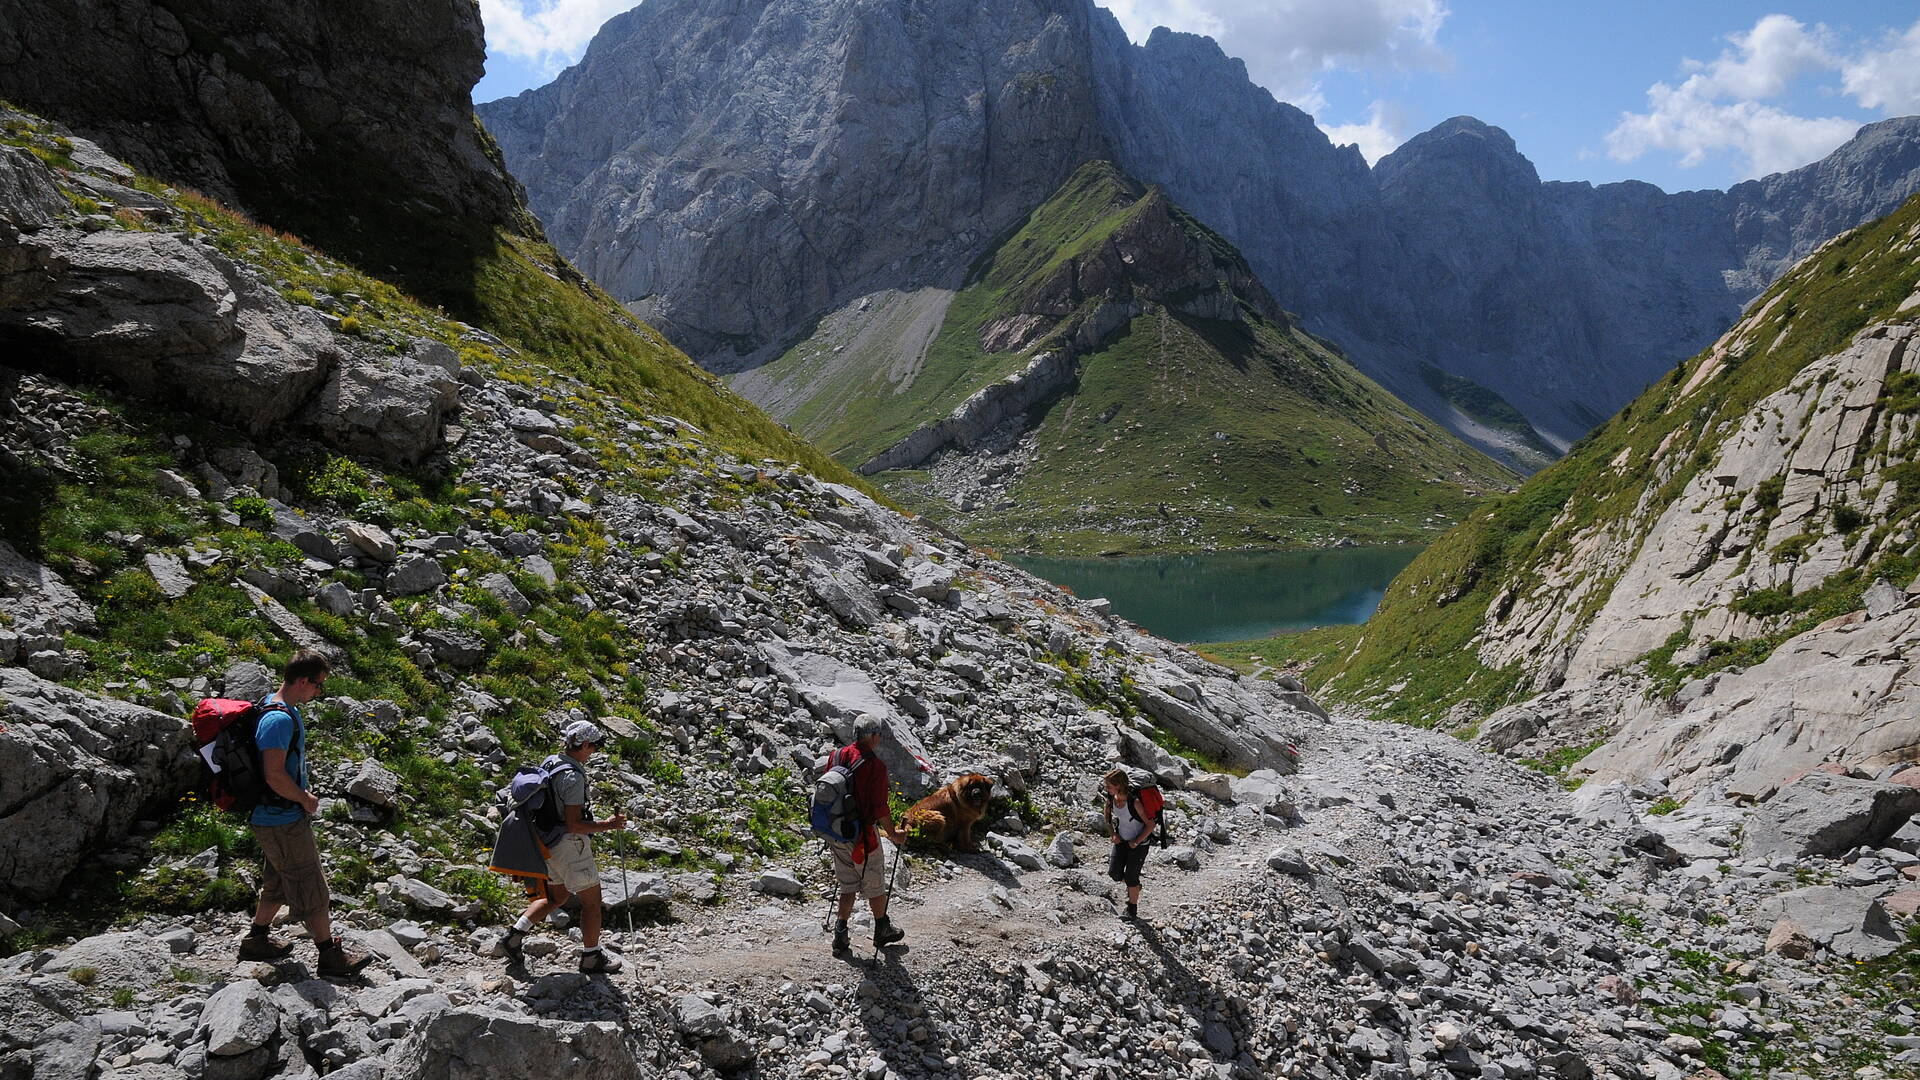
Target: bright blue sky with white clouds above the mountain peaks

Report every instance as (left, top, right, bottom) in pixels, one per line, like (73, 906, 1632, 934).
(474, 0, 1920, 190)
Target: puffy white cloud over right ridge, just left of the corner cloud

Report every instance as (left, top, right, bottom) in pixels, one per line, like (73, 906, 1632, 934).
(1607, 15, 1860, 177)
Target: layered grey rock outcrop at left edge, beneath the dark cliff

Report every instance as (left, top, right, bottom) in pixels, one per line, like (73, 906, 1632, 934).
(0, 125, 461, 463)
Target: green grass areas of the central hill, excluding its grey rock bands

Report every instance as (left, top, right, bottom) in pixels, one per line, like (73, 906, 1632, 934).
(741, 161, 1515, 553)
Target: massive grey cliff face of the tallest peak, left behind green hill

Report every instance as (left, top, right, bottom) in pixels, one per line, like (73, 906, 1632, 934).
(482, 0, 1104, 369)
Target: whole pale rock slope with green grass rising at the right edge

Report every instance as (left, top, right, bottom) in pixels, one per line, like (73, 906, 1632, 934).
(1352, 198, 1920, 798)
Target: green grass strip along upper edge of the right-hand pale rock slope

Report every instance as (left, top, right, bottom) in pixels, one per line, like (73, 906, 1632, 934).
(1292, 198, 1920, 724)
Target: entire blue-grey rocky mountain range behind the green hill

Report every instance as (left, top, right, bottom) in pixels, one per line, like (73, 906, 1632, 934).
(480, 0, 1920, 446)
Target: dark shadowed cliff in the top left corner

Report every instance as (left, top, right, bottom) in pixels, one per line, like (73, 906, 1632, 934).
(0, 0, 538, 300)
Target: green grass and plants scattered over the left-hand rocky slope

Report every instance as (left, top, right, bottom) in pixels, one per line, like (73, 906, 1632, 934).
(0, 105, 814, 937)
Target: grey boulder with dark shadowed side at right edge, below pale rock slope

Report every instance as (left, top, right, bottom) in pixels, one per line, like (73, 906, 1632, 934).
(1740, 773, 1920, 859)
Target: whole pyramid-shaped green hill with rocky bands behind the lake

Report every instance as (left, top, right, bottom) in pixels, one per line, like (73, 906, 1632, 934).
(732, 161, 1511, 553)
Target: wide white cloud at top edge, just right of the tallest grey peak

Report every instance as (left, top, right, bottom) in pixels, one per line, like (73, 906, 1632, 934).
(1106, 0, 1448, 104)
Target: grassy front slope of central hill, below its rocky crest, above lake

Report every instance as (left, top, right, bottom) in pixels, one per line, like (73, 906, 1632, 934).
(968, 307, 1505, 553)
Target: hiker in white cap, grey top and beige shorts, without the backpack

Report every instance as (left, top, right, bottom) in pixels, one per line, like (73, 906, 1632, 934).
(505, 721, 626, 974)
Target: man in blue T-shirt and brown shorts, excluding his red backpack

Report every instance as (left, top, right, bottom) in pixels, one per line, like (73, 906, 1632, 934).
(240, 650, 369, 976)
